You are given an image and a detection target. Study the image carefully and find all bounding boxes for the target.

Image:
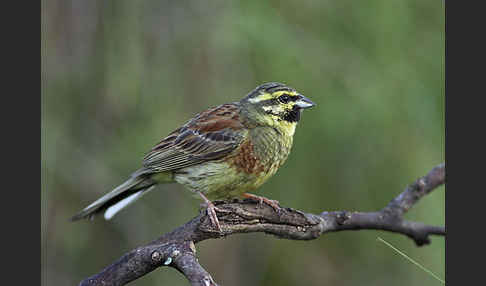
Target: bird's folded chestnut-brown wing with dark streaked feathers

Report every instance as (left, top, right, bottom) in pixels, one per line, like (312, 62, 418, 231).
(143, 103, 247, 173)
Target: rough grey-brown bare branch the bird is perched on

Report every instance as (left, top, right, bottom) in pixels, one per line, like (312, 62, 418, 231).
(79, 164, 445, 286)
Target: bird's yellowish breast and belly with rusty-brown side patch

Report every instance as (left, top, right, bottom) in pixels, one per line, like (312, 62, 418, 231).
(175, 127, 292, 200)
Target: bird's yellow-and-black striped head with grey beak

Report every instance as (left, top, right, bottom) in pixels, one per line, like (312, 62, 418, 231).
(240, 82, 315, 130)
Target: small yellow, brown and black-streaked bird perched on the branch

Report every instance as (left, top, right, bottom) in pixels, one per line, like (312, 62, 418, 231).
(71, 82, 315, 230)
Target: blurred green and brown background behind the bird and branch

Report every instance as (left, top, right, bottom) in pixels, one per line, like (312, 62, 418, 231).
(41, 0, 445, 285)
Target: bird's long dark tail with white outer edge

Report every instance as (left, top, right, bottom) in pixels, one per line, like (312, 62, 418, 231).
(71, 172, 156, 221)
